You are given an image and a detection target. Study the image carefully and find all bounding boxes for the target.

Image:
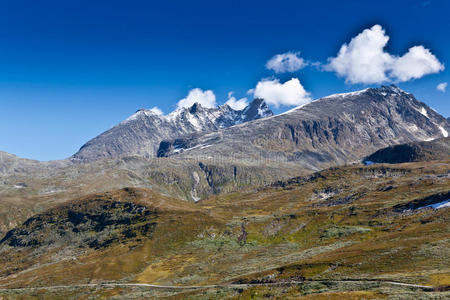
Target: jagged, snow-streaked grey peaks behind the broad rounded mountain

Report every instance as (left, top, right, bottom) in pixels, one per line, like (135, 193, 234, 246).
(71, 99, 273, 161)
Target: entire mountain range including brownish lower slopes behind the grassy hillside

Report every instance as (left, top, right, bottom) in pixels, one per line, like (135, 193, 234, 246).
(0, 85, 450, 201)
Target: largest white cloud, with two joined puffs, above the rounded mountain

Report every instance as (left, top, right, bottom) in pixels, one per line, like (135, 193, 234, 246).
(325, 25, 444, 84)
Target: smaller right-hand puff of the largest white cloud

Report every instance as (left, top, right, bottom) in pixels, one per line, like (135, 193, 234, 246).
(391, 46, 444, 81)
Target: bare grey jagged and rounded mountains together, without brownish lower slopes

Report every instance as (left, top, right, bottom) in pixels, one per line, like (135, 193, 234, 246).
(71, 86, 450, 166)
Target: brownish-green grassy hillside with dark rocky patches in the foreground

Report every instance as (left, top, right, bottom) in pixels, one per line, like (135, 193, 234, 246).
(0, 161, 450, 299)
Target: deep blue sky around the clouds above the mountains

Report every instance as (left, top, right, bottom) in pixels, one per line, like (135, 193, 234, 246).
(0, 0, 450, 160)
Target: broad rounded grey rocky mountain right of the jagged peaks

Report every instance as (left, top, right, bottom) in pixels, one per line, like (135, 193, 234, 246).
(159, 86, 450, 170)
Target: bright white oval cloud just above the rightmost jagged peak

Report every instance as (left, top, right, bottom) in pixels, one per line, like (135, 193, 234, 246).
(254, 78, 312, 107)
